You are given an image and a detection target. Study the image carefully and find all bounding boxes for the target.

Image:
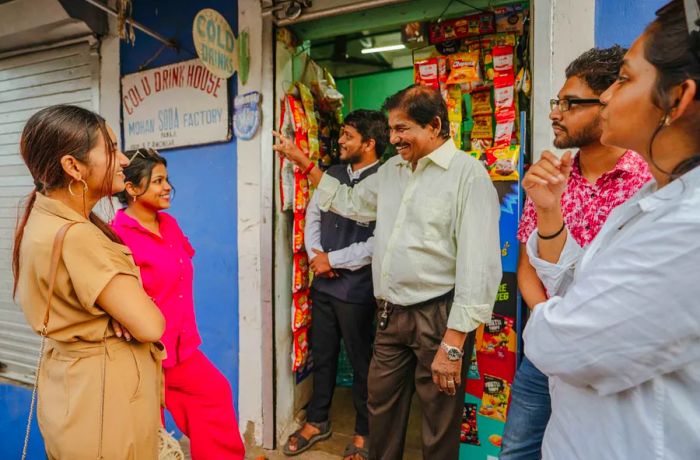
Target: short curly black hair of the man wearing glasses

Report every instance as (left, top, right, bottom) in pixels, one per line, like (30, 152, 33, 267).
(566, 45, 627, 94)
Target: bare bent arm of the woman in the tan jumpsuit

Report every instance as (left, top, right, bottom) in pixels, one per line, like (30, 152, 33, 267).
(97, 274, 165, 342)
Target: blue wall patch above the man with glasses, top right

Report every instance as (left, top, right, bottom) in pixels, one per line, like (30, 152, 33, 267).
(595, 0, 667, 48)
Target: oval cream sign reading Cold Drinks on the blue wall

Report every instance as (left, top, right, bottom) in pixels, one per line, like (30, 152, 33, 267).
(192, 8, 238, 78)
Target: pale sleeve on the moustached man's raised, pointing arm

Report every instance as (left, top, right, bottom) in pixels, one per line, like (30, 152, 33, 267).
(316, 168, 381, 222)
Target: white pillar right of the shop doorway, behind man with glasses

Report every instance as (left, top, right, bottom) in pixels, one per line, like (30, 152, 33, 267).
(531, 0, 595, 160)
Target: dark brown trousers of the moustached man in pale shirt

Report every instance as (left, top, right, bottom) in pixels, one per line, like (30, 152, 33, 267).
(368, 295, 474, 460)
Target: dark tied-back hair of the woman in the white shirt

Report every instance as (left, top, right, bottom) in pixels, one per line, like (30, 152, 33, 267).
(644, 0, 700, 180)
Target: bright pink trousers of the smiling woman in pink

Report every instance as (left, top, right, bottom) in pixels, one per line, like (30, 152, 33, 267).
(165, 350, 245, 460)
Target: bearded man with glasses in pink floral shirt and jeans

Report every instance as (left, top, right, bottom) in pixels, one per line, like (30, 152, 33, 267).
(499, 46, 651, 460)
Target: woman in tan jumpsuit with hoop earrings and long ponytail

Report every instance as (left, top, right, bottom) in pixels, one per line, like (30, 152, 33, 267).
(13, 106, 164, 460)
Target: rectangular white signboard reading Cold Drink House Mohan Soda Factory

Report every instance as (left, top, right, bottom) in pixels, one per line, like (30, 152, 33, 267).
(122, 59, 231, 150)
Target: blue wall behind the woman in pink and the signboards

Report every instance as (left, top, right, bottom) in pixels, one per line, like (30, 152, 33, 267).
(121, 0, 238, 429)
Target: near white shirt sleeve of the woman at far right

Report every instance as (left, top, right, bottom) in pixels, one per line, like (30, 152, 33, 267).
(524, 220, 700, 396)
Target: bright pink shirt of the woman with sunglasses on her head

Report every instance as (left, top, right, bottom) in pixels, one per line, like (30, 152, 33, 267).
(112, 210, 202, 368)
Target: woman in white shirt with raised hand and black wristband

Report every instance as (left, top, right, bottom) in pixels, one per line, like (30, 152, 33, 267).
(523, 0, 700, 460)
